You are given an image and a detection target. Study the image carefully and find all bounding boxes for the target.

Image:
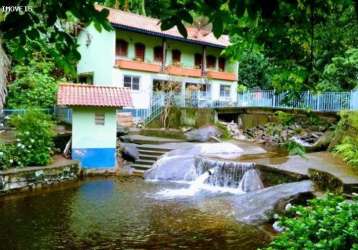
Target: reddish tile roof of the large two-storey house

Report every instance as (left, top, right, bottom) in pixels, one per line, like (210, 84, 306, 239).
(95, 5, 230, 47)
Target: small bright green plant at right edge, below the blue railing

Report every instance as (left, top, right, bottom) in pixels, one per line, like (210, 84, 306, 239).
(333, 136, 358, 169)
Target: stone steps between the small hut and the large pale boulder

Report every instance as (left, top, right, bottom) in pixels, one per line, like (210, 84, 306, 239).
(132, 144, 170, 176)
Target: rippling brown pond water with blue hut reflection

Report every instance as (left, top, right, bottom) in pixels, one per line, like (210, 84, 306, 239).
(0, 178, 268, 249)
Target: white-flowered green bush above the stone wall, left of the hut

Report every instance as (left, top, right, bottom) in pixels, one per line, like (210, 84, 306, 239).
(0, 110, 55, 168)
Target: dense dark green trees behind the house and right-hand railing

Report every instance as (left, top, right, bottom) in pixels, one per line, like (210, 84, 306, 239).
(153, 0, 358, 94)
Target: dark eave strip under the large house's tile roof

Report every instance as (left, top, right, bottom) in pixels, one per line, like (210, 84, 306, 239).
(111, 22, 227, 49)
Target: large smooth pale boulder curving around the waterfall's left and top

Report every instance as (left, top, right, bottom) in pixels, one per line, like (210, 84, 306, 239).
(144, 143, 243, 181)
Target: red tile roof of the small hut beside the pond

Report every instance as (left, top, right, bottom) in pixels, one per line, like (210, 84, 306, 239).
(57, 83, 133, 107)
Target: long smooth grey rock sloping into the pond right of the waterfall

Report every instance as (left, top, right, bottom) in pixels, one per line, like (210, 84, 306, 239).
(231, 180, 313, 224)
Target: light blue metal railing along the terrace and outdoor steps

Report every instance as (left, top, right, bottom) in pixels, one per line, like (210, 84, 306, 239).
(7, 90, 358, 124)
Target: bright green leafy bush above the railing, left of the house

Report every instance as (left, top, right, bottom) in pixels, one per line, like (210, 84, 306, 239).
(7, 60, 57, 109)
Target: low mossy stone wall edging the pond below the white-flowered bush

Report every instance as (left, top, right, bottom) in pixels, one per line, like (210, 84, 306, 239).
(0, 160, 80, 196)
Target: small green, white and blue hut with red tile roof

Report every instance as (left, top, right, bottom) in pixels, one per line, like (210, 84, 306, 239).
(57, 83, 132, 169)
